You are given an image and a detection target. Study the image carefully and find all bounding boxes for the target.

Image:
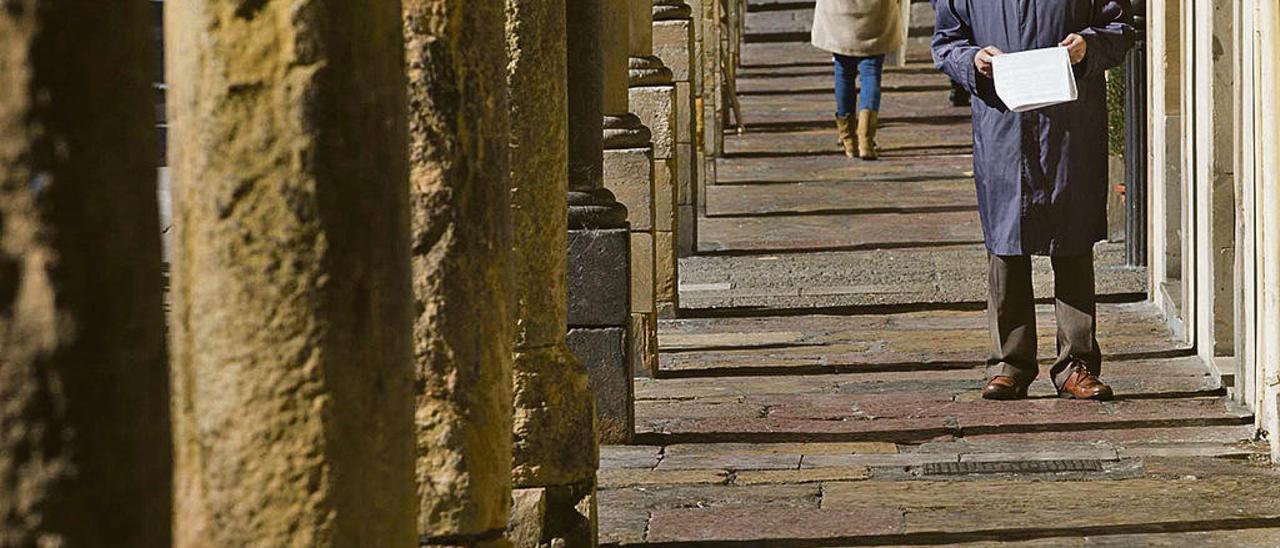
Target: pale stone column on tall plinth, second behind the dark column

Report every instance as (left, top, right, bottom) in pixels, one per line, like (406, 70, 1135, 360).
(627, 0, 680, 322)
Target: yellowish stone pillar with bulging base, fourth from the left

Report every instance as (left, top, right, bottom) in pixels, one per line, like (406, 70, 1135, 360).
(506, 0, 598, 547)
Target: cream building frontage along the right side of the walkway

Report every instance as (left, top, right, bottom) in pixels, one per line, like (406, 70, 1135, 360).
(1146, 0, 1280, 455)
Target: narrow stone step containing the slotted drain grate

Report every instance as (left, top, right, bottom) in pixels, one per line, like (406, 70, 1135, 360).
(599, 440, 1267, 489)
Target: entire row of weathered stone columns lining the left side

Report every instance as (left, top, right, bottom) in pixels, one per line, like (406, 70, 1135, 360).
(0, 0, 747, 547)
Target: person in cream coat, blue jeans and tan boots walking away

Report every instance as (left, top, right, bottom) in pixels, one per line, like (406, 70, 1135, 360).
(813, 0, 902, 160)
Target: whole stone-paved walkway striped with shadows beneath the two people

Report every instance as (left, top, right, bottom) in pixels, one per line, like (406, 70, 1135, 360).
(599, 1, 1280, 547)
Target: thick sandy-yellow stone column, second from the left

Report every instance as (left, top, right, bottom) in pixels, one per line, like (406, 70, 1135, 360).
(163, 0, 421, 547)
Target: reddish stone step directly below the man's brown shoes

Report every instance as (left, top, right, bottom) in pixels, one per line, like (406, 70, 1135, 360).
(636, 394, 1253, 444)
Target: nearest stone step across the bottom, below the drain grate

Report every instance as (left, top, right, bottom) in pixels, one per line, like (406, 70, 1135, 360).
(600, 453, 1280, 545)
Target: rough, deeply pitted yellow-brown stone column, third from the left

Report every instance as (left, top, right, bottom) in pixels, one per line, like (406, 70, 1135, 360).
(403, 0, 512, 545)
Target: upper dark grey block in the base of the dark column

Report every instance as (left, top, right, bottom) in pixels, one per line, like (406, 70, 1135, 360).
(568, 228, 631, 326)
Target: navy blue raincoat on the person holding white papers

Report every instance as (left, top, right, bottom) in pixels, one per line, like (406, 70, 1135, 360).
(933, 0, 1134, 255)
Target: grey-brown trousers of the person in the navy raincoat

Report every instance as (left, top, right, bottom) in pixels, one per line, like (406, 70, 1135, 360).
(987, 252, 1102, 387)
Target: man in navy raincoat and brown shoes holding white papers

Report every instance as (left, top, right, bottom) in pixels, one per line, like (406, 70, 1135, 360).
(933, 0, 1134, 399)
